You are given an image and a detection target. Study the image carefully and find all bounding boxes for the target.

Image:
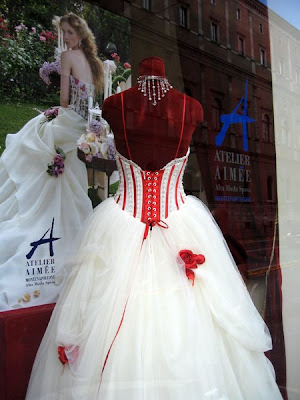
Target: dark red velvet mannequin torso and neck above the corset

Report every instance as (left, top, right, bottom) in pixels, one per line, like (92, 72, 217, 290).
(102, 57, 203, 171)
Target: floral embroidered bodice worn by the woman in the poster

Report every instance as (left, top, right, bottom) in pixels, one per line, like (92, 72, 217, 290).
(70, 75, 95, 119)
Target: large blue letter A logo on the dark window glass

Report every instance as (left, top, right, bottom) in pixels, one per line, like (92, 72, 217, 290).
(215, 78, 255, 151)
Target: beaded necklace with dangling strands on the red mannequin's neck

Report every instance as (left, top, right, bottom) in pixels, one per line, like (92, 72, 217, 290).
(138, 75, 173, 106)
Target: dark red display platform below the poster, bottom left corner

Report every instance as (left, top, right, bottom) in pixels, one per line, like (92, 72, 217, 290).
(0, 304, 54, 400)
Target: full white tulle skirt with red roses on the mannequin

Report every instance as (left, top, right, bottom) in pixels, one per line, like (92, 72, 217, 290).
(26, 197, 281, 400)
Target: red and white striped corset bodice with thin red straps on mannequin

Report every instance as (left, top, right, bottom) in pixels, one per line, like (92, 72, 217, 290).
(114, 93, 190, 238)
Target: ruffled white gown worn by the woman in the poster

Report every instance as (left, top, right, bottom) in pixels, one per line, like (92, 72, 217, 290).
(0, 77, 93, 311)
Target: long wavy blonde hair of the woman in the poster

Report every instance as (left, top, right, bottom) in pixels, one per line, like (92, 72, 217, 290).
(56, 12, 104, 93)
